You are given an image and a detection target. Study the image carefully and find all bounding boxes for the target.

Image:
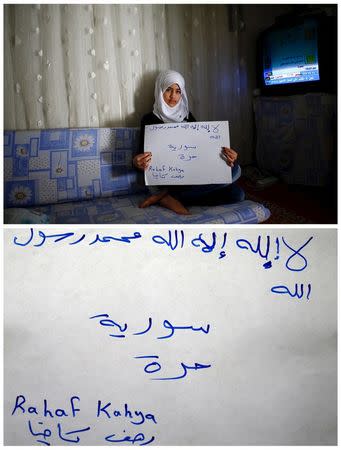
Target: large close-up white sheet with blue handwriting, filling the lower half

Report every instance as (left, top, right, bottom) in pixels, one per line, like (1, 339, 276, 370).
(4, 226, 337, 446)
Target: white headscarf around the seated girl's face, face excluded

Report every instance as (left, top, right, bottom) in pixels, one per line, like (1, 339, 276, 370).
(153, 70, 189, 122)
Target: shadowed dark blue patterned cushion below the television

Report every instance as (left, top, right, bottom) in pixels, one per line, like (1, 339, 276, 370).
(254, 93, 337, 187)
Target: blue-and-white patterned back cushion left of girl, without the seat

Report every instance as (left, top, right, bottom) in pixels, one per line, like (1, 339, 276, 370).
(4, 128, 143, 207)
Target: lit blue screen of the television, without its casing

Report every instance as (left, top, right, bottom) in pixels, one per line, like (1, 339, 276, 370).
(263, 18, 320, 86)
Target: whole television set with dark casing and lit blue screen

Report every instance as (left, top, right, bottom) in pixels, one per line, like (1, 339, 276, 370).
(257, 14, 337, 95)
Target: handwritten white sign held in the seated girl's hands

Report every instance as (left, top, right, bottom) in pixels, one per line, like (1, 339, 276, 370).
(144, 121, 232, 185)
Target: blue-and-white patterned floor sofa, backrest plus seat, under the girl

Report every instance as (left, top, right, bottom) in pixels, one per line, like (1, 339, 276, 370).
(4, 128, 270, 224)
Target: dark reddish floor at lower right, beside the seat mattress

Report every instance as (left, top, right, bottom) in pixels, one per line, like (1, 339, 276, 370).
(238, 177, 337, 224)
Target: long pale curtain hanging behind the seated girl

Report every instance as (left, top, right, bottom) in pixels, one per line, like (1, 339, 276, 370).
(4, 4, 252, 159)
